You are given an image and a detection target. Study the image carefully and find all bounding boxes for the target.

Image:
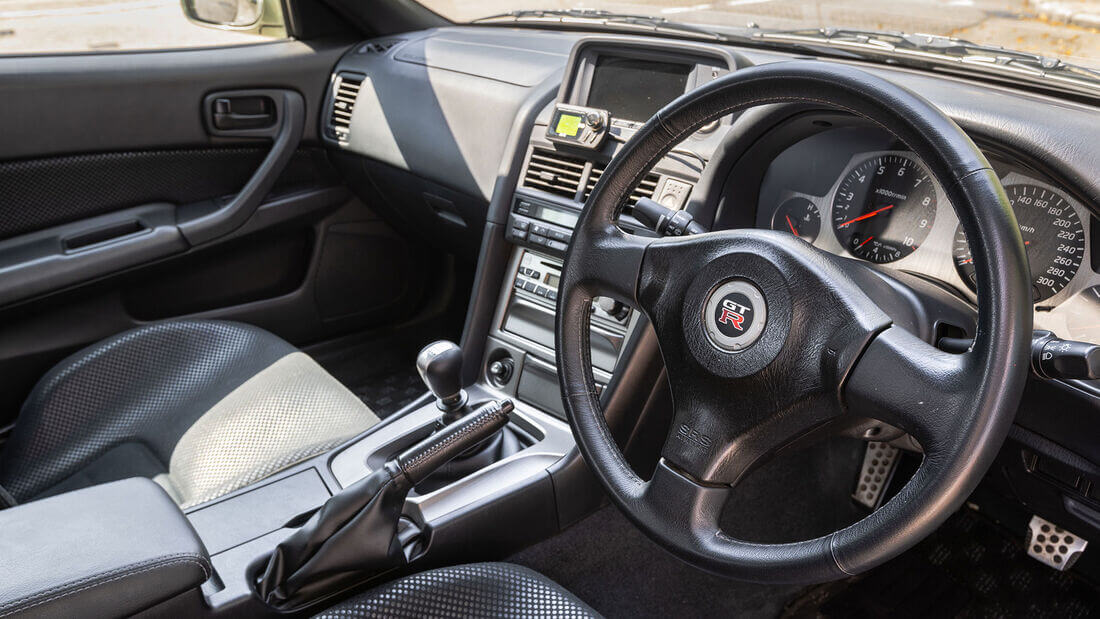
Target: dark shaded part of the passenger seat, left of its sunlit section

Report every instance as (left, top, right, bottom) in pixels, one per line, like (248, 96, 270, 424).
(0, 320, 296, 501)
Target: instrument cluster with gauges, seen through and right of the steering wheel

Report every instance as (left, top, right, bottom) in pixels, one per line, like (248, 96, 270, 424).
(755, 126, 1100, 343)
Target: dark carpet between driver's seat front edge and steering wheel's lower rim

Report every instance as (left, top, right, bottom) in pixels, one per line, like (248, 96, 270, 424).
(509, 507, 801, 618)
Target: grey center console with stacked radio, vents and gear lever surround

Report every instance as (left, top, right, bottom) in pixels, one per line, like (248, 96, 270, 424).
(135, 36, 736, 616)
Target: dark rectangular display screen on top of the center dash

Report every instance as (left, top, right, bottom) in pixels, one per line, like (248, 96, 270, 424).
(586, 56, 692, 122)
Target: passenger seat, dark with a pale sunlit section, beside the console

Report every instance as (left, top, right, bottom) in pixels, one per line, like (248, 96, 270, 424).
(0, 320, 378, 508)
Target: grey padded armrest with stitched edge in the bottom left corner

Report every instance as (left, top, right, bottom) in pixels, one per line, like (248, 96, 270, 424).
(0, 478, 212, 617)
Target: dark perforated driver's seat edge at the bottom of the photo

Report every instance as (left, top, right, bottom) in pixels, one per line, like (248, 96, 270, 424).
(317, 563, 600, 619)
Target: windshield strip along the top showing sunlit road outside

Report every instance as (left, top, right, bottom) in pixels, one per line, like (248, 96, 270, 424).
(421, 0, 1100, 68)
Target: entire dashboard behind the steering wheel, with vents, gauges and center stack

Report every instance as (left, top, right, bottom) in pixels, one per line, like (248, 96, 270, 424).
(321, 26, 1100, 554)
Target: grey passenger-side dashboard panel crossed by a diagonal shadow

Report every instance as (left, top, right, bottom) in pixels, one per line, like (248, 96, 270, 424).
(329, 27, 573, 201)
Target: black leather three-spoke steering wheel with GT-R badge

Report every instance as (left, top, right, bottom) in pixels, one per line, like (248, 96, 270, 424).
(556, 60, 1032, 583)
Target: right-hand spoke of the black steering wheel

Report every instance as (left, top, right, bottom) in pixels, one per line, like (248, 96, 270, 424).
(844, 327, 972, 451)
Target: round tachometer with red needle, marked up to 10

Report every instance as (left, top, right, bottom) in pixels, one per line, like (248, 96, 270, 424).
(833, 155, 936, 264)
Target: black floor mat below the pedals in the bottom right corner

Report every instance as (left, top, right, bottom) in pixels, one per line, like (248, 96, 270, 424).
(784, 509, 1100, 619)
